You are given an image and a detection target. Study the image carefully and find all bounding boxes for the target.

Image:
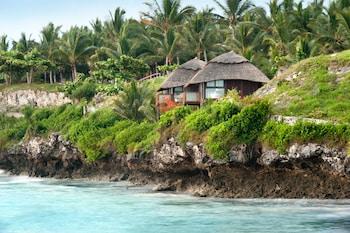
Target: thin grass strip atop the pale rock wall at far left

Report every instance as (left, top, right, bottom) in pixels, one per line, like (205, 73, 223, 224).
(0, 83, 62, 92)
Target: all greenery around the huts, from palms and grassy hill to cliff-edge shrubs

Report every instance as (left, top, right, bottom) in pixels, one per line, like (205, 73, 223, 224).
(0, 0, 350, 161)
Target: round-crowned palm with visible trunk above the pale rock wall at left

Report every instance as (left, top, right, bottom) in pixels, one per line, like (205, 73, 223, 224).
(59, 27, 95, 80)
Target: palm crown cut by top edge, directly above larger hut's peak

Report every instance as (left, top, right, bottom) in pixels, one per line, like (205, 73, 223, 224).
(214, 0, 253, 29)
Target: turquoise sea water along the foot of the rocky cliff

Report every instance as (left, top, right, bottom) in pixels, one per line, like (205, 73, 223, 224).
(0, 169, 350, 233)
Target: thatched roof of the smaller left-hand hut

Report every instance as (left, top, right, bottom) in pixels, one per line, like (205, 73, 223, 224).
(159, 58, 206, 91)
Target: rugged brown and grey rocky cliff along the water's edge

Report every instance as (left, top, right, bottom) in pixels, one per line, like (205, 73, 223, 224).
(0, 134, 350, 198)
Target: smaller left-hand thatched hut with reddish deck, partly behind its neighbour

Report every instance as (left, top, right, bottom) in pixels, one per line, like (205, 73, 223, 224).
(156, 58, 206, 112)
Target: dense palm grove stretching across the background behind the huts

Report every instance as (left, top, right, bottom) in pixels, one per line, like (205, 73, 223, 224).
(0, 0, 350, 84)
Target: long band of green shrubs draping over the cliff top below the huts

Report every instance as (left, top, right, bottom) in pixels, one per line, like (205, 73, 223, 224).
(0, 95, 350, 161)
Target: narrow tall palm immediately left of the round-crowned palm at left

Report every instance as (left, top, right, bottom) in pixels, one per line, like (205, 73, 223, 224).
(41, 23, 61, 83)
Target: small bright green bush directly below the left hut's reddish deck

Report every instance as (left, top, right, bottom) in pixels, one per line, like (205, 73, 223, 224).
(158, 106, 192, 129)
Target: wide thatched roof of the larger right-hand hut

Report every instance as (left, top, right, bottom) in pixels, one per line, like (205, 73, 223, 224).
(187, 52, 269, 85)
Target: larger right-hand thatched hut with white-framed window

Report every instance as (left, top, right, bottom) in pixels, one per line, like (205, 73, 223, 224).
(184, 52, 269, 105)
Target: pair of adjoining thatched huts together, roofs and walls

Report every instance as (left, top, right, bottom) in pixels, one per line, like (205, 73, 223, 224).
(157, 52, 269, 112)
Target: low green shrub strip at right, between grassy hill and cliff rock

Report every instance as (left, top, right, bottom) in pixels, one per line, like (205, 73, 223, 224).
(261, 120, 350, 153)
